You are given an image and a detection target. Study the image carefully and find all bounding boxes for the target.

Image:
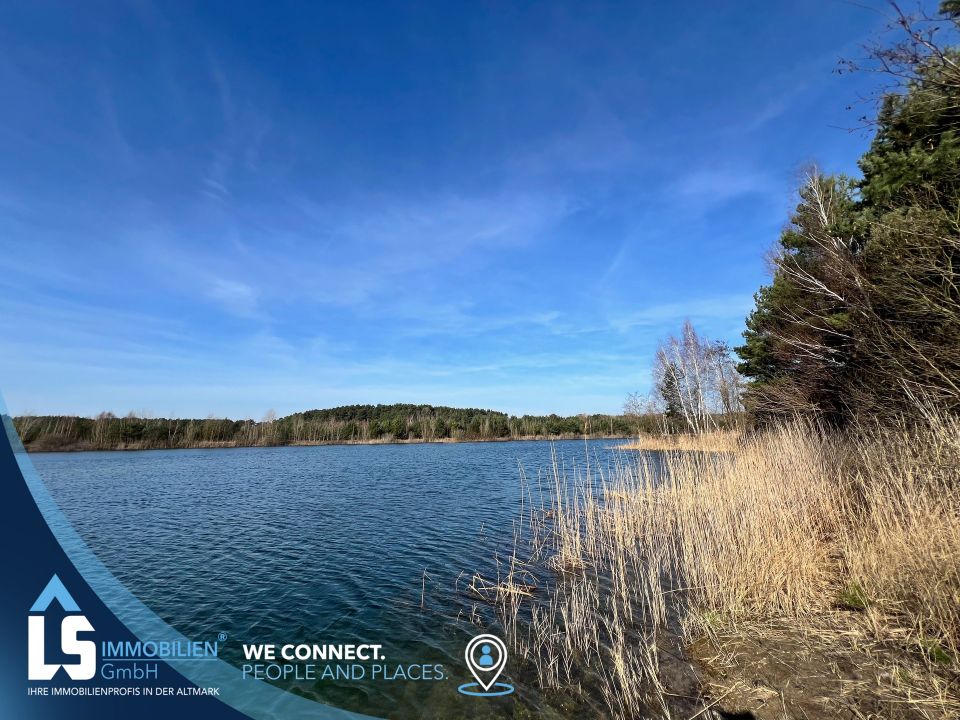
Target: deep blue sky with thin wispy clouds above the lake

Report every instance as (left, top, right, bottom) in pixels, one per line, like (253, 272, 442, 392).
(0, 0, 916, 418)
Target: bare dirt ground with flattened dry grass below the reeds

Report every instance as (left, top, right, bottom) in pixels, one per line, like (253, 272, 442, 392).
(687, 612, 960, 720)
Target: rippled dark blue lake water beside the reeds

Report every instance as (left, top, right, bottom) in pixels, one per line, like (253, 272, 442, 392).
(31, 440, 632, 718)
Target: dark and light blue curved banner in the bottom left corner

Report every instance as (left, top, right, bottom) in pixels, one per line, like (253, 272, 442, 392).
(0, 398, 382, 720)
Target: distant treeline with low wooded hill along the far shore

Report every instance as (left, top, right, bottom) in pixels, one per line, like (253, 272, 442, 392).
(14, 404, 659, 451)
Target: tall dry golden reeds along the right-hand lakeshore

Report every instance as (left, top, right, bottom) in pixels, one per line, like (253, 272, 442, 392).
(489, 414, 960, 718)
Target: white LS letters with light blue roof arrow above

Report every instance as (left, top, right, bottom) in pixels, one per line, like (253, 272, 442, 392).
(27, 575, 97, 680)
